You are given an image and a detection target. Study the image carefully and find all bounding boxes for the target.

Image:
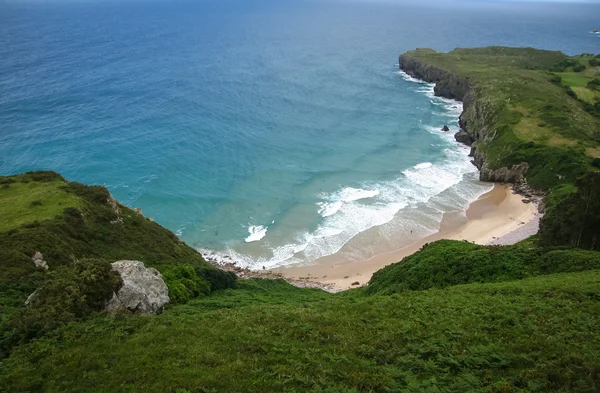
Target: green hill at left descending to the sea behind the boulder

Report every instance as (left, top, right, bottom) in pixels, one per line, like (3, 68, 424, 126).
(0, 172, 234, 357)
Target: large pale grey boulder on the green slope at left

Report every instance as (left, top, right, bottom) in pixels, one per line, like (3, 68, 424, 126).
(106, 261, 169, 314)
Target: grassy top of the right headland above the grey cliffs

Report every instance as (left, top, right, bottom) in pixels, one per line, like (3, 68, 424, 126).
(398, 47, 600, 190)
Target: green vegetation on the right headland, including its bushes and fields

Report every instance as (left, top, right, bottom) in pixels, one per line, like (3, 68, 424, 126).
(403, 47, 600, 250)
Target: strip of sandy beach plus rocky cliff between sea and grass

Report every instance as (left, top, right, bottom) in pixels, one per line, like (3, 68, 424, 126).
(207, 62, 541, 292)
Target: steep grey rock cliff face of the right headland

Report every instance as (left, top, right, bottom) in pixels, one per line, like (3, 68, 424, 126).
(399, 54, 529, 183)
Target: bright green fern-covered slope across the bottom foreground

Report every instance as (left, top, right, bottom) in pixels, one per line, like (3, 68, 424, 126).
(0, 270, 600, 393)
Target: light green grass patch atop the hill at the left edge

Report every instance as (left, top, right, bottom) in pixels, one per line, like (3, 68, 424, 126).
(0, 175, 81, 232)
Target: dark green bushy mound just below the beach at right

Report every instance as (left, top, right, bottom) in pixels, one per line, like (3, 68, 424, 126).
(365, 240, 600, 294)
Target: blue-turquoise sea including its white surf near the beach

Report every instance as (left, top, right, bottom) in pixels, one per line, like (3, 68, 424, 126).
(0, 0, 600, 267)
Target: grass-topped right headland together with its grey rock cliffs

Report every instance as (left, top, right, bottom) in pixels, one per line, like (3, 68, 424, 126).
(399, 47, 600, 191)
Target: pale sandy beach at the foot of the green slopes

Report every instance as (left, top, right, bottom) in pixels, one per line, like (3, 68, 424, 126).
(275, 184, 539, 290)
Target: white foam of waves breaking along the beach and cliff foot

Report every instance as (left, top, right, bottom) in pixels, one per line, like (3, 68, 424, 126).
(204, 72, 490, 268)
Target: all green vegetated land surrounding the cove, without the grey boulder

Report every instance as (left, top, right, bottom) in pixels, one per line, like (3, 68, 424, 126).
(0, 48, 600, 393)
